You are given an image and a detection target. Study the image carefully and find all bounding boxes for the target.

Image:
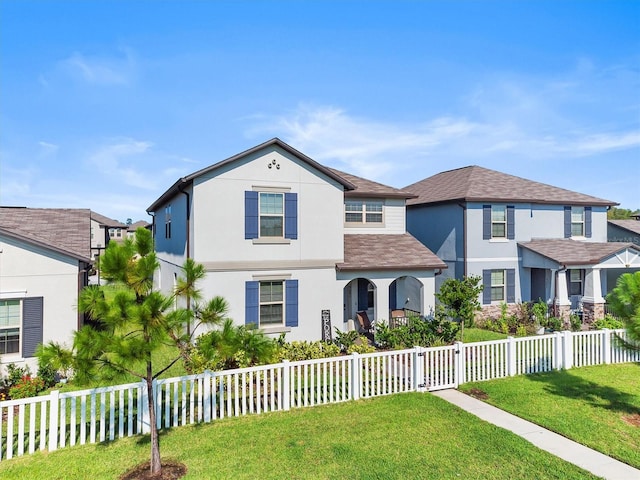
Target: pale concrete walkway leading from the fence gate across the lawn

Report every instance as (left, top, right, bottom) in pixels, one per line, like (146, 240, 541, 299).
(431, 390, 640, 480)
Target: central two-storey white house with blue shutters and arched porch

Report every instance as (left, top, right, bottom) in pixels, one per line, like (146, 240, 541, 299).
(147, 139, 446, 340)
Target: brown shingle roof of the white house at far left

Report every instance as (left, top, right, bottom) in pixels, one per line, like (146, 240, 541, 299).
(0, 207, 91, 263)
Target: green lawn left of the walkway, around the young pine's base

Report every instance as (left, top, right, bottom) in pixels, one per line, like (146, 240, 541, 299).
(0, 393, 596, 480)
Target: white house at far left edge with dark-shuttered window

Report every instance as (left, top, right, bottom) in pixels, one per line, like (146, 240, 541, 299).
(0, 207, 91, 373)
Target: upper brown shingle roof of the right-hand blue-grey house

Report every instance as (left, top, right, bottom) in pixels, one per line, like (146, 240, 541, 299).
(403, 165, 618, 206)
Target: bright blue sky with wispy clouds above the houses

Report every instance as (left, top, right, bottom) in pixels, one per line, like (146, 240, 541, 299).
(0, 0, 640, 221)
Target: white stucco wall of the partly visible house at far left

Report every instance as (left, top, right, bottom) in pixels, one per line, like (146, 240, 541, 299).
(0, 236, 78, 373)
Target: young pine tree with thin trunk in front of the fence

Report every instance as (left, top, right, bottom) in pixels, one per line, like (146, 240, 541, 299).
(40, 228, 228, 474)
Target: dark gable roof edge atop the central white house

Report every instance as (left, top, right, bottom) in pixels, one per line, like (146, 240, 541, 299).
(147, 138, 355, 212)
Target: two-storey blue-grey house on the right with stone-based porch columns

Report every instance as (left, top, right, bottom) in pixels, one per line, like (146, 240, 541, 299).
(404, 166, 640, 321)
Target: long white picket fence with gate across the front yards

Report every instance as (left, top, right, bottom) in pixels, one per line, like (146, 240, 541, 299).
(0, 330, 640, 460)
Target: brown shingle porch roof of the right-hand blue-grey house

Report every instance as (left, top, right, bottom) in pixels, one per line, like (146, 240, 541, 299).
(518, 238, 640, 265)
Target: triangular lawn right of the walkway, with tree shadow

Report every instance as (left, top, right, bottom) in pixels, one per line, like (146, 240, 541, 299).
(460, 363, 640, 468)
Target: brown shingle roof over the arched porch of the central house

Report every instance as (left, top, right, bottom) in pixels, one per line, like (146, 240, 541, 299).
(336, 233, 447, 270)
